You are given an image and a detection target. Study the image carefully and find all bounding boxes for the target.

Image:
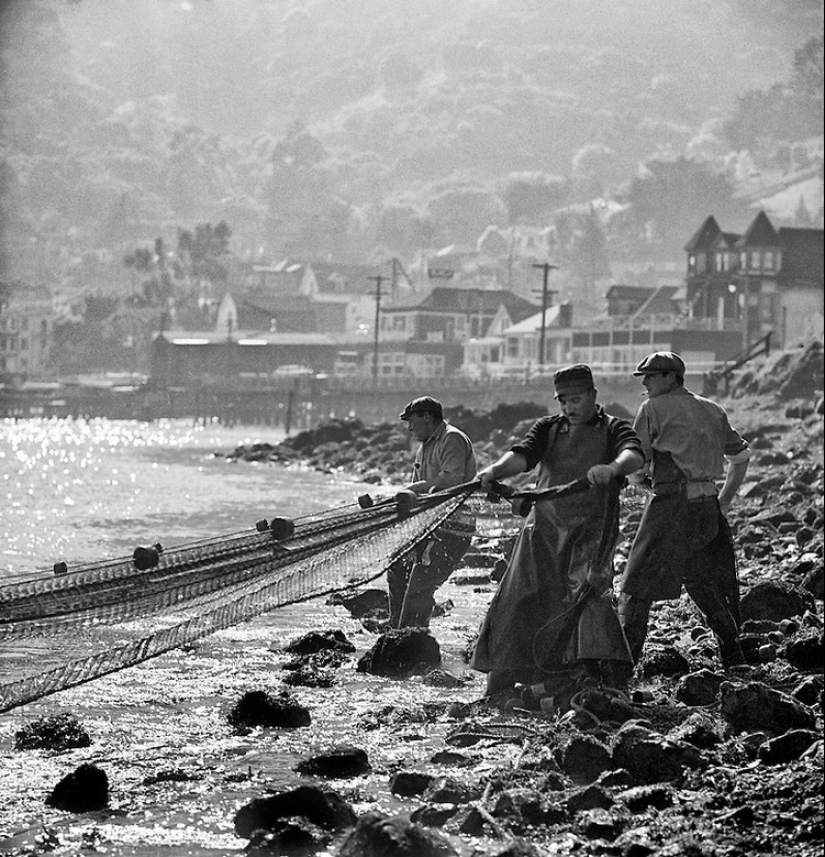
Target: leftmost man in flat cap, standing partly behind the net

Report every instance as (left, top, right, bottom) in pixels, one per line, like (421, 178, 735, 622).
(387, 396, 476, 628)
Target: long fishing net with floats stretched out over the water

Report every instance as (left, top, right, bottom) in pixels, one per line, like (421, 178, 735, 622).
(0, 486, 482, 711)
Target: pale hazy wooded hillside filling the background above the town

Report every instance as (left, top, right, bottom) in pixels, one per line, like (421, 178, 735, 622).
(0, 0, 823, 279)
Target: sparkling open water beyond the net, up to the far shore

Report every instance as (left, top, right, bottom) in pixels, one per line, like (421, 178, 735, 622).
(0, 419, 364, 582)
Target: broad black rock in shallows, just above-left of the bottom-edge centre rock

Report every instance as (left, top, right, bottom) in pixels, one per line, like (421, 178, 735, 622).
(234, 786, 356, 839)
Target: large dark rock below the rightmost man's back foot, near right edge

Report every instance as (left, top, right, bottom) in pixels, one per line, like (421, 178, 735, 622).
(720, 681, 816, 735)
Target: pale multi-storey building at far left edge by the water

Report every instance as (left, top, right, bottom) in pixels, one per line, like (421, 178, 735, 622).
(0, 282, 55, 379)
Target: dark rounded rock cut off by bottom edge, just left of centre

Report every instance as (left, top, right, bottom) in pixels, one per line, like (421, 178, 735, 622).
(338, 812, 457, 857)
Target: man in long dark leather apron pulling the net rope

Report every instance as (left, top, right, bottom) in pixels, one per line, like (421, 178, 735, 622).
(470, 363, 644, 697)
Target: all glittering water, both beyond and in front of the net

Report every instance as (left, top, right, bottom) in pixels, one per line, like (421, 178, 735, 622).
(0, 420, 492, 857)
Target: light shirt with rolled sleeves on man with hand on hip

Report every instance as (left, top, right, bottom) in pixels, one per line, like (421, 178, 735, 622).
(633, 387, 748, 494)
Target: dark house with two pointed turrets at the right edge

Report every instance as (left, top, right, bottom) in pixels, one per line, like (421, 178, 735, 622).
(685, 211, 825, 349)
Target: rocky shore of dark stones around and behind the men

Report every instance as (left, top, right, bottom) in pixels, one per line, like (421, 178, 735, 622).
(216, 344, 825, 857)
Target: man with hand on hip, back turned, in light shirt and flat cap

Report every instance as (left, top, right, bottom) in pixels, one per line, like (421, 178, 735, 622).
(619, 351, 750, 667)
